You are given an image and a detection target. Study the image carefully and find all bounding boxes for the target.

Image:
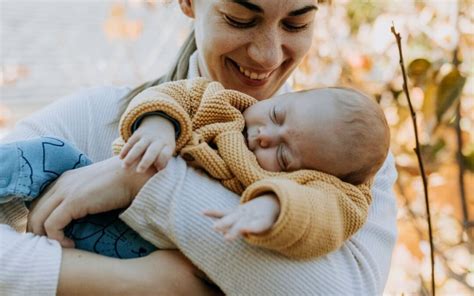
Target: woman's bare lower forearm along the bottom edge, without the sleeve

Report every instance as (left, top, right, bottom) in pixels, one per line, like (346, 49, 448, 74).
(57, 249, 219, 296)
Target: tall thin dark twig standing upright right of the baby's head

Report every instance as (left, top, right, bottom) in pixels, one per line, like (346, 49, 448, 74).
(391, 24, 436, 296)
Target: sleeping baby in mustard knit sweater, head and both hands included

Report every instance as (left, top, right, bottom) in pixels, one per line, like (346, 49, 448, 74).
(114, 78, 390, 258)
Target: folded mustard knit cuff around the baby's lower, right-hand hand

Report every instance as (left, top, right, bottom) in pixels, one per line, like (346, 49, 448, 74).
(241, 178, 311, 253)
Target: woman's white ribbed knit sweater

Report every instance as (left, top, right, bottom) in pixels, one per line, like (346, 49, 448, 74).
(0, 53, 396, 295)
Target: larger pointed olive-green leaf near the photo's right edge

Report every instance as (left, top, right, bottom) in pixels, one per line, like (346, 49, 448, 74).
(436, 68, 466, 122)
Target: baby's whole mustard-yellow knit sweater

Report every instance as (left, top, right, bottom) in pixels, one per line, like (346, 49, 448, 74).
(113, 78, 372, 259)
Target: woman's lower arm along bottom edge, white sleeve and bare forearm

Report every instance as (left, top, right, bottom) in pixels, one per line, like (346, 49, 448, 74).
(0, 225, 219, 296)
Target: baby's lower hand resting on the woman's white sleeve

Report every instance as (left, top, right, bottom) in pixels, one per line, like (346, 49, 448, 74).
(204, 194, 280, 240)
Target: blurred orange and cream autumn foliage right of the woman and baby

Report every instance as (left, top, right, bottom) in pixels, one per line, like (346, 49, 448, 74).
(294, 0, 474, 295)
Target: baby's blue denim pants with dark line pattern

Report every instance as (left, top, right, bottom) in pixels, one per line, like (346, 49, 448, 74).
(0, 137, 156, 258)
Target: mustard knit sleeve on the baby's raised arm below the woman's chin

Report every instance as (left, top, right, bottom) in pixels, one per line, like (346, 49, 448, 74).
(118, 78, 213, 151)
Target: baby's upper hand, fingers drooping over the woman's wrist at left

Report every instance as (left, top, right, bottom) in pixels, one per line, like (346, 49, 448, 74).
(119, 116, 176, 173)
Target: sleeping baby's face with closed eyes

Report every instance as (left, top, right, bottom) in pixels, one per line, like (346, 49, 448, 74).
(244, 90, 339, 172)
